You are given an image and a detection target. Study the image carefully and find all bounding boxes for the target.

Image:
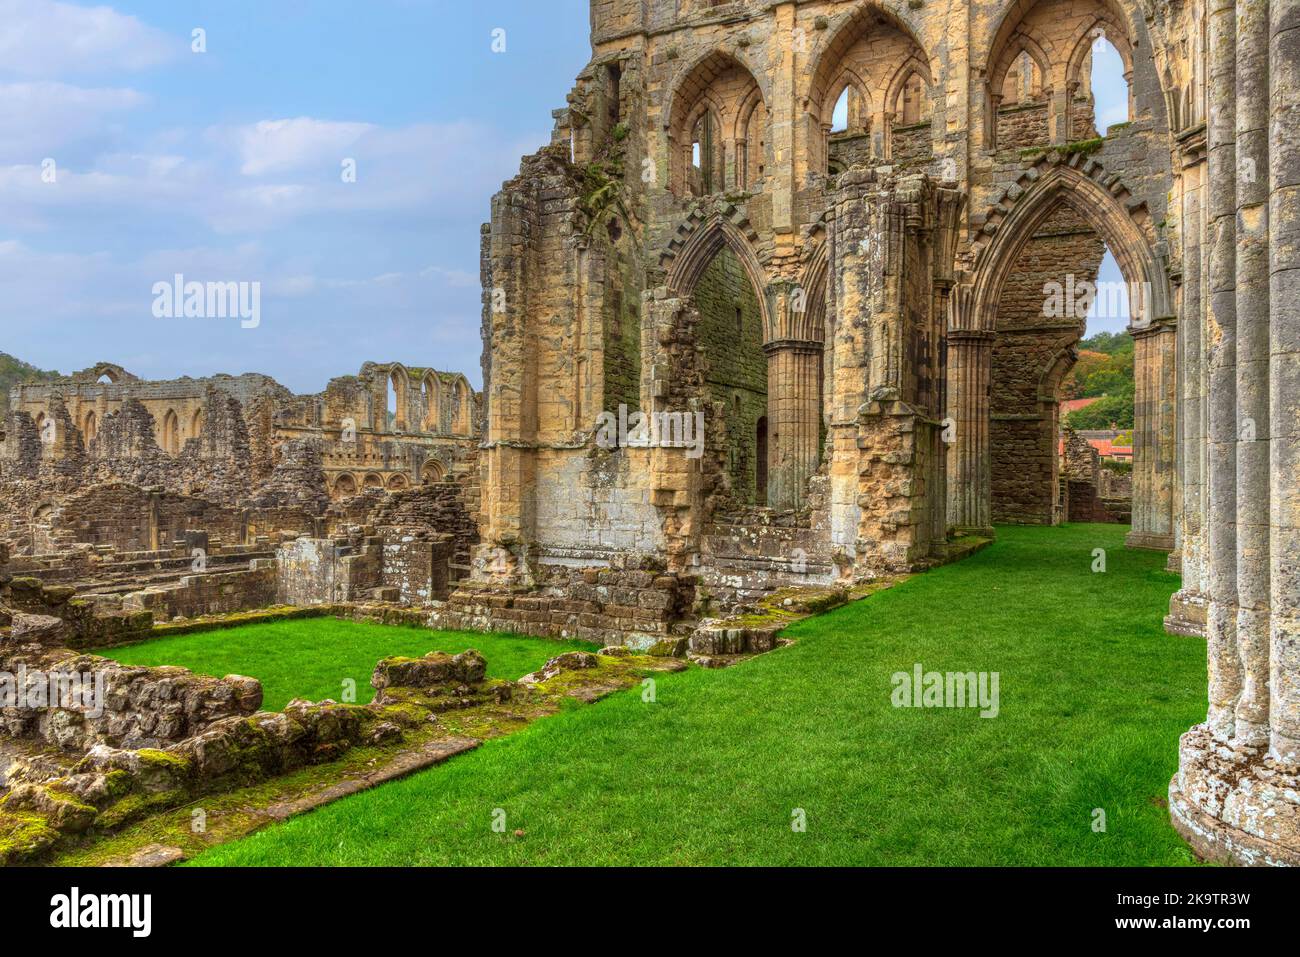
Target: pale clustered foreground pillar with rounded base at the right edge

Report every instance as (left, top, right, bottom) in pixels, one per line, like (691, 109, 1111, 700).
(1170, 0, 1300, 865)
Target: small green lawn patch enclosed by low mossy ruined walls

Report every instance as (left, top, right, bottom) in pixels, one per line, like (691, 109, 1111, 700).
(96, 618, 599, 711)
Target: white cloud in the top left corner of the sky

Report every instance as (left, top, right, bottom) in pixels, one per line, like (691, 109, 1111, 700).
(0, 0, 180, 78)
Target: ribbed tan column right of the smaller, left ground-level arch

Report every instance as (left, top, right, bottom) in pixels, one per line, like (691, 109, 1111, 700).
(764, 339, 822, 508)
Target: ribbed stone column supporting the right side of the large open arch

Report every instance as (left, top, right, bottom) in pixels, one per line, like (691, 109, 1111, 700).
(1125, 320, 1178, 551)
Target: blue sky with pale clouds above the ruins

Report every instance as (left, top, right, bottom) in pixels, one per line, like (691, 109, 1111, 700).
(0, 0, 1122, 391)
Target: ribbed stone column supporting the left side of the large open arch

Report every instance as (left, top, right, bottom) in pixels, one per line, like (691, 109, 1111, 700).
(948, 328, 993, 536)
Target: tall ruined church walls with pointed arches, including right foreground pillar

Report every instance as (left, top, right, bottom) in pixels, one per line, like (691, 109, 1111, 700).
(476, 0, 1300, 863)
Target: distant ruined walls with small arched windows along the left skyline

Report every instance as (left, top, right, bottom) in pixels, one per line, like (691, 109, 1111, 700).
(0, 363, 478, 554)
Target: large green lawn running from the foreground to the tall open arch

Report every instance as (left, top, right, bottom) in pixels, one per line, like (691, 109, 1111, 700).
(188, 525, 1205, 865)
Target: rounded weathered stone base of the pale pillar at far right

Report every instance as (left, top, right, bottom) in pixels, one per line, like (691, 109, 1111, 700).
(1169, 724, 1300, 867)
